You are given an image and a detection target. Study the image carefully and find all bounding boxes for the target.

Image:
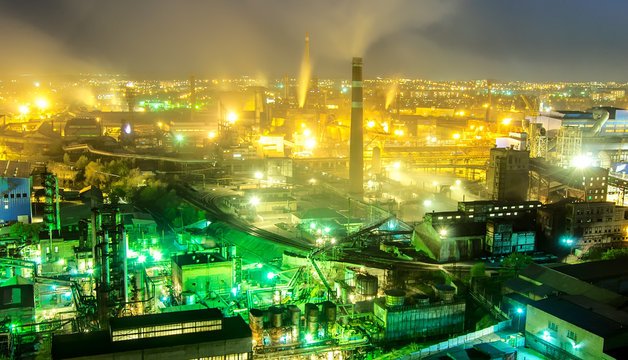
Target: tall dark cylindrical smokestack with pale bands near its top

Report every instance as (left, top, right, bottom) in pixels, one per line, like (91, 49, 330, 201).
(349, 57, 364, 195)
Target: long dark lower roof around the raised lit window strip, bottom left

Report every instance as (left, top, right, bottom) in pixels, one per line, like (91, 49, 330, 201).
(51, 316, 251, 359)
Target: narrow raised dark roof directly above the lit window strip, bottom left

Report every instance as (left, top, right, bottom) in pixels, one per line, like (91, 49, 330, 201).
(109, 309, 223, 331)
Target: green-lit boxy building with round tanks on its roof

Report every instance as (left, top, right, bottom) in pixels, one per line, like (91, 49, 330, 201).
(374, 285, 466, 340)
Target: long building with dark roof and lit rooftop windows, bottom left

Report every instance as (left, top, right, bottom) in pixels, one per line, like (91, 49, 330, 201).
(52, 309, 253, 360)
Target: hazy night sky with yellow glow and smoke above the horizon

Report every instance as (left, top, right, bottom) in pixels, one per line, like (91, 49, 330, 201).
(0, 0, 628, 81)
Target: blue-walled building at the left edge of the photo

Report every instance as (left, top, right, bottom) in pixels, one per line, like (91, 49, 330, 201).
(0, 160, 32, 223)
